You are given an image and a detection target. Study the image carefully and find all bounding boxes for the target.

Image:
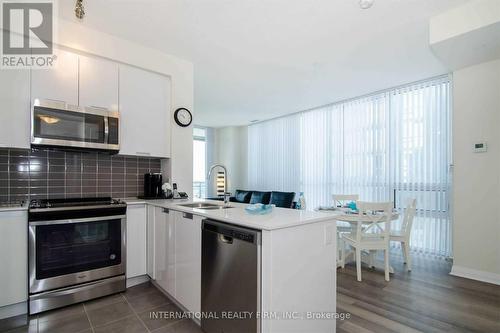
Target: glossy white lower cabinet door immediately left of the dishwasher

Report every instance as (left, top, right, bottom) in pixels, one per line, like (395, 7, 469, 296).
(175, 212, 202, 312)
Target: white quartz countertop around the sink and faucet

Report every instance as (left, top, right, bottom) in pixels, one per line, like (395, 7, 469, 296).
(124, 199, 337, 230)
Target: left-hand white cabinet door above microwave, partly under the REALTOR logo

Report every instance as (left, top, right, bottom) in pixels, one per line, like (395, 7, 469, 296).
(31, 49, 78, 105)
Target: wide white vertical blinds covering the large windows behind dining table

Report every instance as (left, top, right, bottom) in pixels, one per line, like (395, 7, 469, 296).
(248, 76, 451, 256)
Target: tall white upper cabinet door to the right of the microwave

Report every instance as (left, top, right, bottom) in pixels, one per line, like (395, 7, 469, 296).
(119, 65, 171, 158)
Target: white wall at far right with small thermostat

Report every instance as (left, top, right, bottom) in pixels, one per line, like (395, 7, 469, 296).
(452, 60, 500, 284)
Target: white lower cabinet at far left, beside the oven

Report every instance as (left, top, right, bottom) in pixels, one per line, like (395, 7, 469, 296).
(0, 211, 28, 307)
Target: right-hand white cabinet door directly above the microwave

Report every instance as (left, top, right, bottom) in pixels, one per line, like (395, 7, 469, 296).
(79, 56, 119, 111)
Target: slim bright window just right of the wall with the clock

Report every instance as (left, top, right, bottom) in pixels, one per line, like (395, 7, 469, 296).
(193, 127, 207, 198)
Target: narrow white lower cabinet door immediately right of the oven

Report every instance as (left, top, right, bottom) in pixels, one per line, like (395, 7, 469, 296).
(126, 204, 146, 279)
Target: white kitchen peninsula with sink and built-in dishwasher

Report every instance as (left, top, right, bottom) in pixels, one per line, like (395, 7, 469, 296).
(125, 199, 336, 332)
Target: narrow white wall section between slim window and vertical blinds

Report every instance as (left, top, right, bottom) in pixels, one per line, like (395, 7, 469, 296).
(208, 126, 248, 195)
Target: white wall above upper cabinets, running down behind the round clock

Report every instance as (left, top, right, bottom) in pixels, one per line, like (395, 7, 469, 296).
(58, 19, 194, 196)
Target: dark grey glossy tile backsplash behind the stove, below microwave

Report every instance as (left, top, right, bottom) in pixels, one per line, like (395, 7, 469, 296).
(0, 149, 161, 202)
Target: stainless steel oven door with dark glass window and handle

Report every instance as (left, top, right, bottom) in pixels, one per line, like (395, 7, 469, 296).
(29, 215, 126, 293)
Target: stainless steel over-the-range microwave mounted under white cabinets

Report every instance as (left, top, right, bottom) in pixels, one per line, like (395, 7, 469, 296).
(31, 99, 120, 153)
